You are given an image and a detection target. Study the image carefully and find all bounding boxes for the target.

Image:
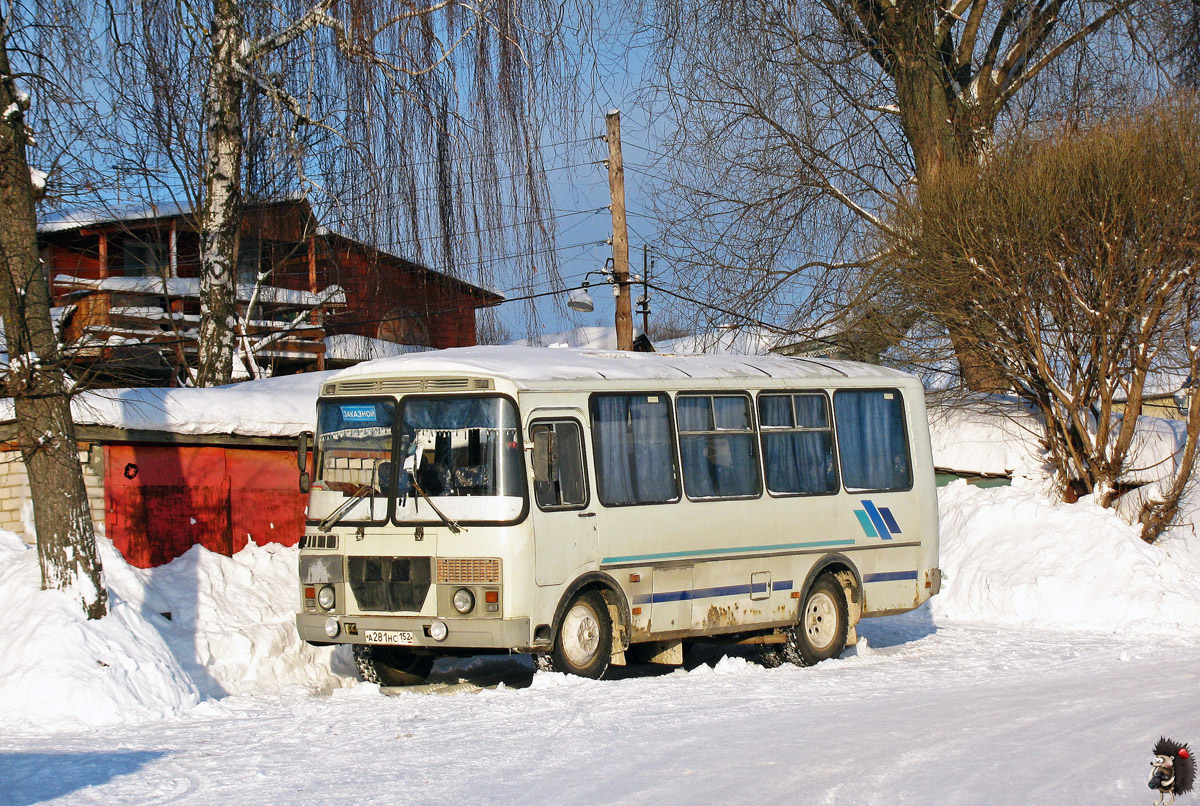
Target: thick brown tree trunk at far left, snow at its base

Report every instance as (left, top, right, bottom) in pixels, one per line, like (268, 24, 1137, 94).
(0, 35, 108, 619)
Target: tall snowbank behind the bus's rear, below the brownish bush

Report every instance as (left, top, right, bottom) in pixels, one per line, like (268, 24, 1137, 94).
(932, 481, 1200, 636)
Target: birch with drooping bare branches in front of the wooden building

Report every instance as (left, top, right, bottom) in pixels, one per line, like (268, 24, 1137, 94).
(104, 0, 570, 385)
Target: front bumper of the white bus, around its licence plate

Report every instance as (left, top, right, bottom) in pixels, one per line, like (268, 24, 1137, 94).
(296, 613, 530, 649)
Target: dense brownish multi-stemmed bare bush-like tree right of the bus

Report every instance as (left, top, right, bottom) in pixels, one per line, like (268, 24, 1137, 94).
(888, 97, 1200, 540)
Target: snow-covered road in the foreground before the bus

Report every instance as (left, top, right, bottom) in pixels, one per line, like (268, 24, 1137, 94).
(0, 609, 1200, 806)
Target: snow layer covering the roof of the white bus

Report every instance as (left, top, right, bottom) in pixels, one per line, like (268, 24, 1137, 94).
(332, 345, 911, 385)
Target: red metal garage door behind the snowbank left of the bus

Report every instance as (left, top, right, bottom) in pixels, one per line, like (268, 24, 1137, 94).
(104, 444, 307, 569)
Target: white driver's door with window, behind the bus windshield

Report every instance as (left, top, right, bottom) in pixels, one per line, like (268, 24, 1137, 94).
(529, 411, 598, 585)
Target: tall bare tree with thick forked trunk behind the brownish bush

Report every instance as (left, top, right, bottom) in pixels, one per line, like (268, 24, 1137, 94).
(634, 0, 1180, 389)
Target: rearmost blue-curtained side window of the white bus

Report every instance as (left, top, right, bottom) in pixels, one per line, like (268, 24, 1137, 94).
(833, 389, 912, 492)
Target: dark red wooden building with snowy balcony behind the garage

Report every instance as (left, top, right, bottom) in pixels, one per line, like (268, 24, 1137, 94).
(38, 199, 503, 386)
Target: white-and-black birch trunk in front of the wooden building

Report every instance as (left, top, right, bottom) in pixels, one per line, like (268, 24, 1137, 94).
(196, 0, 245, 386)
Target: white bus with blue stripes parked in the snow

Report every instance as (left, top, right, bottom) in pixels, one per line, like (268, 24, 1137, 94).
(296, 347, 941, 685)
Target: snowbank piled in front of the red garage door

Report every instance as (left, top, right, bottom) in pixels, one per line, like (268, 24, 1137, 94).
(0, 533, 354, 730)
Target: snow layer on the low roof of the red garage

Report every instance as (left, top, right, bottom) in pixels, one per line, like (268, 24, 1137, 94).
(0, 372, 332, 437)
